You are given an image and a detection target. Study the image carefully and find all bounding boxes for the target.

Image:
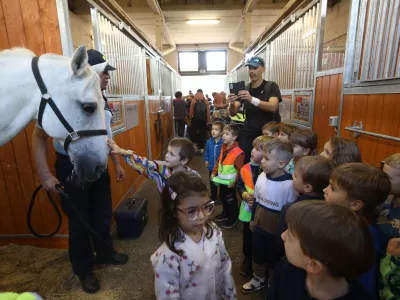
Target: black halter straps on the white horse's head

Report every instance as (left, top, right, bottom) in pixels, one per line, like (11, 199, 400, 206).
(32, 56, 107, 153)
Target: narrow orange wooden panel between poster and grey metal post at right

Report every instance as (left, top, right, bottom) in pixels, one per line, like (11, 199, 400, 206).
(313, 73, 343, 153)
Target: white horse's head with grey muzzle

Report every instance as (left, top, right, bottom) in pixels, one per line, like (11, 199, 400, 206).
(40, 46, 109, 181)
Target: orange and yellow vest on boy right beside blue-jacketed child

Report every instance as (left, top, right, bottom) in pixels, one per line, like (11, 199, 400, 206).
(213, 147, 243, 185)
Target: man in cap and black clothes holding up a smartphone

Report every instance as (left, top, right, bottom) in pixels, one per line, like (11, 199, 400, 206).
(228, 56, 282, 163)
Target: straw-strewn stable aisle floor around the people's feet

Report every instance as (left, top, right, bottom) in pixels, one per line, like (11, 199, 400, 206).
(0, 156, 265, 300)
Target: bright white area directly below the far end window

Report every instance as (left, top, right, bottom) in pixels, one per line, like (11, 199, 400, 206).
(181, 75, 226, 98)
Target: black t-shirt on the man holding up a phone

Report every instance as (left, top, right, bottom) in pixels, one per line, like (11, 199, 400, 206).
(244, 80, 282, 132)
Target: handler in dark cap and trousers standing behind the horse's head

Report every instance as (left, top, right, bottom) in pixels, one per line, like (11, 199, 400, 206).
(32, 49, 128, 293)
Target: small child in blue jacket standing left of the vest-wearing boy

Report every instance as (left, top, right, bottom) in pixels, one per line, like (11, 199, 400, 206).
(204, 121, 225, 201)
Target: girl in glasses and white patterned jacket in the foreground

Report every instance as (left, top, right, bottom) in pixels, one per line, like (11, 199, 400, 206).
(151, 172, 237, 300)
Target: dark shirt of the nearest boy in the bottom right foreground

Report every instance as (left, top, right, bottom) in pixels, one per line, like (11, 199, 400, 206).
(266, 258, 374, 300)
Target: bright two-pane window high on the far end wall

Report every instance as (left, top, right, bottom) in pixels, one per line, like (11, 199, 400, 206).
(178, 50, 227, 75)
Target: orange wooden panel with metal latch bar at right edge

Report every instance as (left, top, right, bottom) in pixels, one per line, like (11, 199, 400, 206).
(340, 94, 400, 166)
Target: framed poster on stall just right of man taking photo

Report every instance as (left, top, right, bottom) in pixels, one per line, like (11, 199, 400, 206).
(292, 91, 313, 126)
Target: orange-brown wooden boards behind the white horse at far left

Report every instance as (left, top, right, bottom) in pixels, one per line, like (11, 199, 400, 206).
(0, 0, 67, 247)
